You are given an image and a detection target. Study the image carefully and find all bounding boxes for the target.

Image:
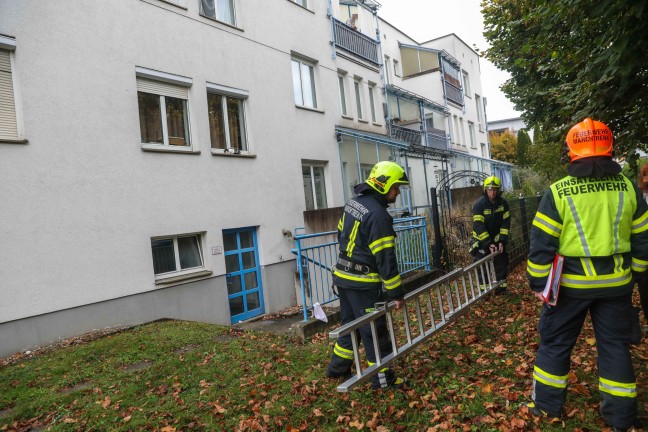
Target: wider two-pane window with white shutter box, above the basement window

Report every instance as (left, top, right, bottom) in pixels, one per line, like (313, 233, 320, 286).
(136, 68, 191, 149)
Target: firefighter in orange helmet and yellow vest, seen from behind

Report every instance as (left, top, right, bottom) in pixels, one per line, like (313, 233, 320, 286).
(524, 118, 648, 431)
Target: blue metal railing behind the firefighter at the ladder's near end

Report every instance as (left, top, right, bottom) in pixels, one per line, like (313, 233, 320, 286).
(292, 216, 430, 321)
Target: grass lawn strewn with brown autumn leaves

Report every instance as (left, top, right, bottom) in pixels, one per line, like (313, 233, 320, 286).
(0, 268, 648, 432)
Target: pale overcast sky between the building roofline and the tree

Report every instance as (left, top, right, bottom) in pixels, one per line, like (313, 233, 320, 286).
(377, 0, 520, 121)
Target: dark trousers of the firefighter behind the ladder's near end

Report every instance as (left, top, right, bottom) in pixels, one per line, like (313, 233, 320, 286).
(328, 287, 396, 388)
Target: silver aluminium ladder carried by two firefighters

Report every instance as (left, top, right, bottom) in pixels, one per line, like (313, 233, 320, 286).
(329, 254, 500, 392)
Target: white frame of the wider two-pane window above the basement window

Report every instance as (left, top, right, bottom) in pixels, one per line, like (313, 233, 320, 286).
(135, 66, 197, 153)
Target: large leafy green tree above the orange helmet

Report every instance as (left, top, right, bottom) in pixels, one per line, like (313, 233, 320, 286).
(482, 0, 648, 176)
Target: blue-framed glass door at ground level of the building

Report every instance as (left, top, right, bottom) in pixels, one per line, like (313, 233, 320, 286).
(223, 227, 264, 324)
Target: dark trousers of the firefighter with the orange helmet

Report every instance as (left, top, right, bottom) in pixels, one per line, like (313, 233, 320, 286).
(532, 294, 637, 430)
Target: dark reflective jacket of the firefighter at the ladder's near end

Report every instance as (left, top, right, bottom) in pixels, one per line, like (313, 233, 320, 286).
(333, 191, 404, 299)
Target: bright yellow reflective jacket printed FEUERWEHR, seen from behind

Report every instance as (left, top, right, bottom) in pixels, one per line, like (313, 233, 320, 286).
(527, 174, 648, 298)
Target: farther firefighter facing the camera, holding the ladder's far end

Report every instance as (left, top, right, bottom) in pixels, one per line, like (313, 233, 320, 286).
(470, 176, 511, 294)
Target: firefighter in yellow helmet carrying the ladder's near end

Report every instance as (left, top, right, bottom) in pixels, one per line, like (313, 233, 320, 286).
(326, 161, 409, 390)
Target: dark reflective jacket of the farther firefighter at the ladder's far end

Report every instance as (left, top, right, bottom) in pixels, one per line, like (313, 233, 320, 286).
(470, 195, 511, 252)
